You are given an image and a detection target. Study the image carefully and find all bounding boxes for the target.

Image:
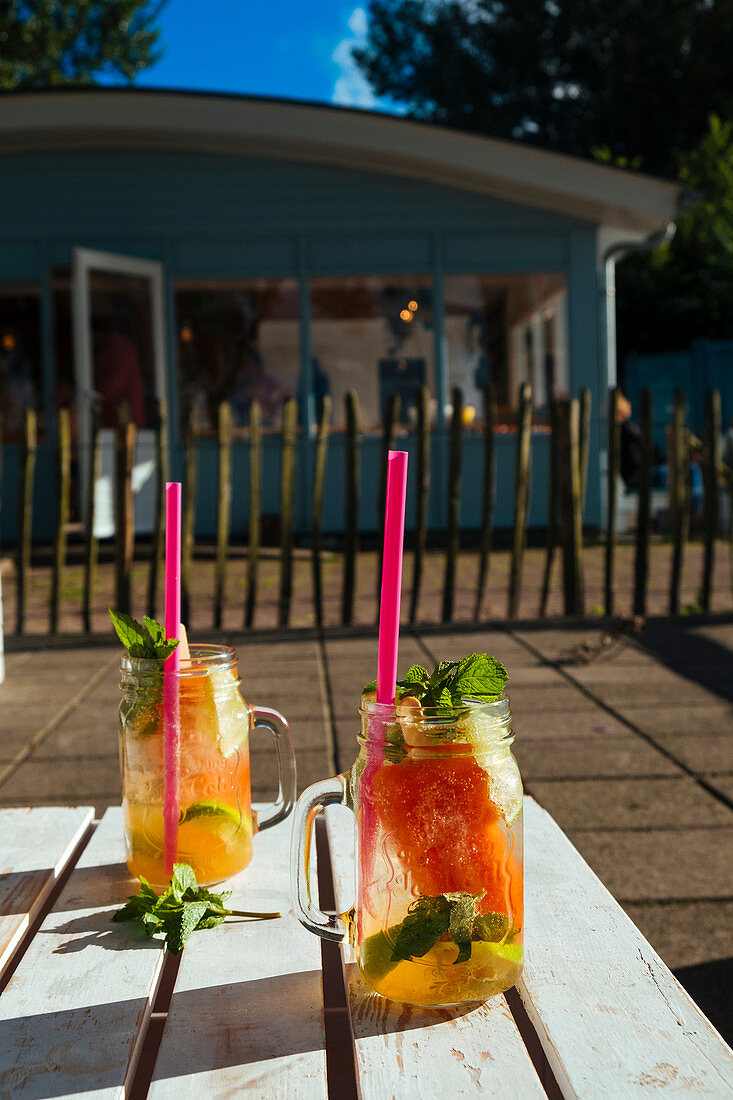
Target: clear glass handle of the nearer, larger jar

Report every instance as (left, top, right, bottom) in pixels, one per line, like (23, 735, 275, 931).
(291, 776, 347, 943)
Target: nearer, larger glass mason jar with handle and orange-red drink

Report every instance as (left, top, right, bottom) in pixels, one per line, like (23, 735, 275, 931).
(292, 696, 524, 1007)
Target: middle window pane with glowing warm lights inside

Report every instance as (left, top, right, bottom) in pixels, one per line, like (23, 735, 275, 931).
(310, 275, 435, 429)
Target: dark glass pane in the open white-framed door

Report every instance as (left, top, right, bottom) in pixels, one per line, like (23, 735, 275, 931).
(89, 272, 155, 428)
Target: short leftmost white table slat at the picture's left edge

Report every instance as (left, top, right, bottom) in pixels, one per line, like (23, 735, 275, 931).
(0, 806, 94, 975)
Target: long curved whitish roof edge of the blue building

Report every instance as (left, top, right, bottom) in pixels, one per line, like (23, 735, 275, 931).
(0, 89, 681, 239)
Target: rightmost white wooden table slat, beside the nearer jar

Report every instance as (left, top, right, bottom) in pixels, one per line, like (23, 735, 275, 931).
(518, 799, 733, 1100)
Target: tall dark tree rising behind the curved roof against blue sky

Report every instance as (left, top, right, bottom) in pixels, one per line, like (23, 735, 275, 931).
(354, 0, 733, 174)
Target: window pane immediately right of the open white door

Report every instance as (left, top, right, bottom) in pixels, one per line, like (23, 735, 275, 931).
(176, 279, 300, 432)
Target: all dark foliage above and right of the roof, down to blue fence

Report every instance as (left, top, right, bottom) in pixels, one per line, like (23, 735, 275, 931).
(354, 0, 733, 347)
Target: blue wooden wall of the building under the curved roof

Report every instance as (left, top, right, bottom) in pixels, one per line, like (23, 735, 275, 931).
(0, 150, 605, 541)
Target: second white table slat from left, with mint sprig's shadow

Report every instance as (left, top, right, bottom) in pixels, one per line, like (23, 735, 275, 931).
(0, 809, 164, 1100)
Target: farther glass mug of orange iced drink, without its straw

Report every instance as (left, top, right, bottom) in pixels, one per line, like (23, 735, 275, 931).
(120, 645, 295, 886)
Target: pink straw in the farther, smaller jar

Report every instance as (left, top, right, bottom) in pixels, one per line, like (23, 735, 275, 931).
(163, 482, 180, 878)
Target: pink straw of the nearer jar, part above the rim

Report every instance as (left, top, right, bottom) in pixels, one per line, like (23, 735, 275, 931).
(376, 451, 407, 706)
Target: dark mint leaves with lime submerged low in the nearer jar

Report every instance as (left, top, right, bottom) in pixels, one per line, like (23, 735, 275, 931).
(362, 893, 510, 979)
